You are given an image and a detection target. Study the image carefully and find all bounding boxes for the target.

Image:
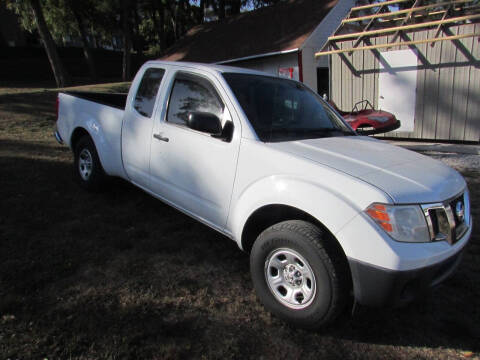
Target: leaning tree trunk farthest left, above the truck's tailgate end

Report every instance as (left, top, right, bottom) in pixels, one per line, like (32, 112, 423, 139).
(30, 0, 70, 87)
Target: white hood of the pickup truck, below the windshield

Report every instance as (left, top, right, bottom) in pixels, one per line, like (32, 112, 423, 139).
(268, 136, 466, 203)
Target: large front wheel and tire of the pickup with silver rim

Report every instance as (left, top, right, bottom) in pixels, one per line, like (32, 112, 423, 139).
(250, 220, 351, 329)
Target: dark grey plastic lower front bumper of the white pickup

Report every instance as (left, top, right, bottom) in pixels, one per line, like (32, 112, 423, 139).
(349, 249, 464, 307)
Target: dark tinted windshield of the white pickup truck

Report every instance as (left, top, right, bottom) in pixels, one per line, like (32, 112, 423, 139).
(223, 73, 355, 142)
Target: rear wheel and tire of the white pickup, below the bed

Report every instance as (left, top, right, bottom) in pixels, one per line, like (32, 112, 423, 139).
(73, 136, 107, 191)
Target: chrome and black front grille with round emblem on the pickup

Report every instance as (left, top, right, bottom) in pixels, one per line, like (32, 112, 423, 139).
(422, 191, 470, 244)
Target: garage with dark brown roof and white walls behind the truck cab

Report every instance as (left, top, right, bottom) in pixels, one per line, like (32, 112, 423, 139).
(160, 0, 355, 94)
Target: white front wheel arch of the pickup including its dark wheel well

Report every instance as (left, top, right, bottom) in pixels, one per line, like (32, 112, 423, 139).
(231, 175, 366, 256)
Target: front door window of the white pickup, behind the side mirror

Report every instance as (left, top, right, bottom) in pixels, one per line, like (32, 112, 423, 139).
(167, 73, 225, 125)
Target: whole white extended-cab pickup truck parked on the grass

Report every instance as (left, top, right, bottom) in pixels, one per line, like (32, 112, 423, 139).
(55, 61, 472, 328)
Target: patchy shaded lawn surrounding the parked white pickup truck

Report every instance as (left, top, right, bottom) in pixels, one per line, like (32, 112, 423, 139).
(0, 84, 480, 359)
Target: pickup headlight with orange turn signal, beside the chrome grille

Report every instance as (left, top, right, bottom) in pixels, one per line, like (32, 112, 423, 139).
(365, 204, 430, 242)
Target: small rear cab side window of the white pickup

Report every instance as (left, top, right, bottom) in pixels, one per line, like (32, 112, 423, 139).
(133, 68, 165, 117)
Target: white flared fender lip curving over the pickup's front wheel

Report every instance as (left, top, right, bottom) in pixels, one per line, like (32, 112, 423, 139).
(227, 175, 386, 256)
